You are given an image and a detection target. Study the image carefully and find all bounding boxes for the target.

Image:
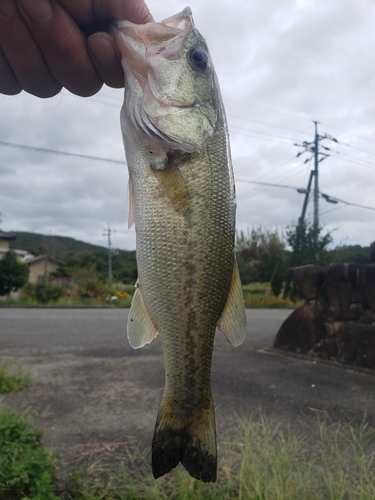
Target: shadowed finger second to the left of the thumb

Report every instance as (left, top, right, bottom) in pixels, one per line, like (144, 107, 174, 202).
(0, 0, 61, 97)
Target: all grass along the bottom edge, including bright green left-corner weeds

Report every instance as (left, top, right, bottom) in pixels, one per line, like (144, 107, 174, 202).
(0, 410, 375, 500)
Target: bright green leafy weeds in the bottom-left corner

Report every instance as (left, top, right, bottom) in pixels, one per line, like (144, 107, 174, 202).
(0, 407, 58, 500)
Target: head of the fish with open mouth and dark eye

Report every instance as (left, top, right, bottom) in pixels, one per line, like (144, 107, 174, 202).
(114, 7, 217, 153)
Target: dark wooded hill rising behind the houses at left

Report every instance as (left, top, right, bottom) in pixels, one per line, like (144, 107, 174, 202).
(9, 231, 105, 260)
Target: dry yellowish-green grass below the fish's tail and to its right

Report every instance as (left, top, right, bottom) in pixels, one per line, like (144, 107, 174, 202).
(64, 416, 375, 500)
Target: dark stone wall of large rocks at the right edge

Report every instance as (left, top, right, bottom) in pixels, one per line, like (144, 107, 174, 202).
(273, 254, 375, 368)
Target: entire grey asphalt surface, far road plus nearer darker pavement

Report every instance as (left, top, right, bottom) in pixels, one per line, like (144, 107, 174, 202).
(0, 308, 375, 474)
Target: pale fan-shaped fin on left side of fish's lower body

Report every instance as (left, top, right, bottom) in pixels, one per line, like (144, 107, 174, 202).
(127, 288, 158, 349)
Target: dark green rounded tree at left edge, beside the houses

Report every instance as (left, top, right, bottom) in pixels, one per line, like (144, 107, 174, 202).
(0, 250, 29, 295)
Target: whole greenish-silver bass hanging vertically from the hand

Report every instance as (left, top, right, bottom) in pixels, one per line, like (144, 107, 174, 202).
(113, 7, 246, 482)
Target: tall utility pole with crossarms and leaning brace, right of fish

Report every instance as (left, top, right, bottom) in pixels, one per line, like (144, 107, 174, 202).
(295, 120, 338, 256)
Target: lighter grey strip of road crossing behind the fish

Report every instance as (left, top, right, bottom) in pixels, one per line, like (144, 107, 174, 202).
(0, 308, 290, 351)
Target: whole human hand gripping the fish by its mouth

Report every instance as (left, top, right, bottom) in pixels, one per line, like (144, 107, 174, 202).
(0, 0, 152, 97)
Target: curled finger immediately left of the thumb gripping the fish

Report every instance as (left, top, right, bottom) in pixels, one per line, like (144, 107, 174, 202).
(19, 0, 103, 97)
